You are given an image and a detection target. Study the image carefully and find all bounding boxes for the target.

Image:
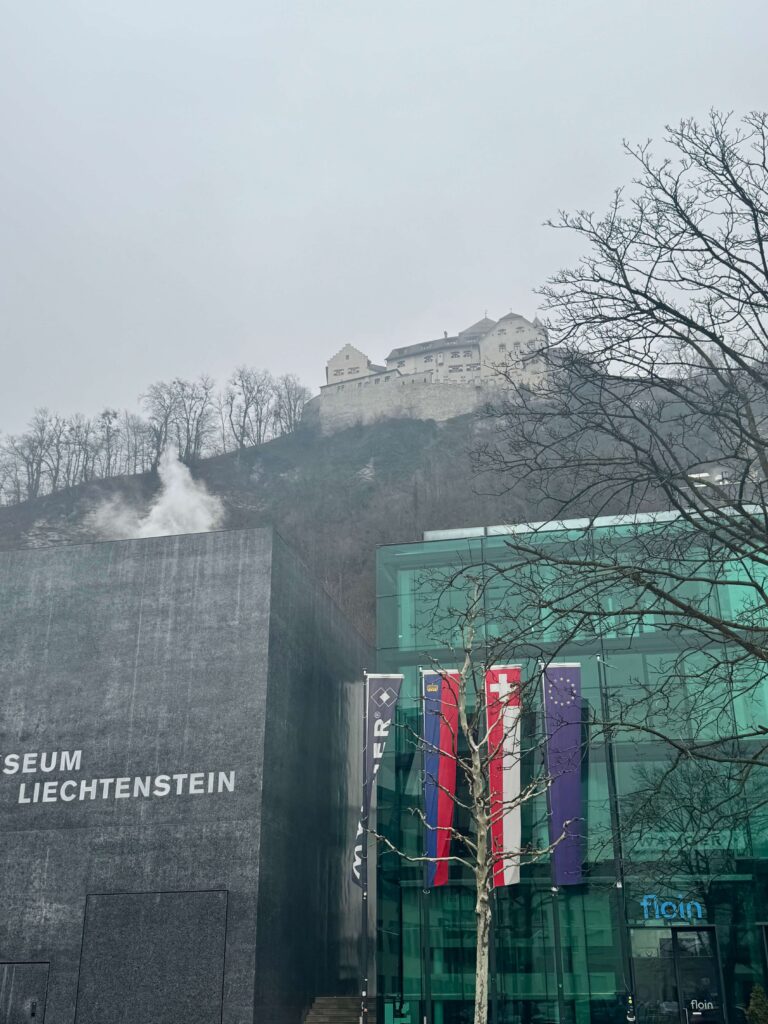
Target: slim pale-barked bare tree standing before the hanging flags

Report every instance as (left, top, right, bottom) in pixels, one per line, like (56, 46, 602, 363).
(374, 585, 561, 1024)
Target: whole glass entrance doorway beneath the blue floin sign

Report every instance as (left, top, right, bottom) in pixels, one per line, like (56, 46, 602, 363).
(632, 928, 725, 1024)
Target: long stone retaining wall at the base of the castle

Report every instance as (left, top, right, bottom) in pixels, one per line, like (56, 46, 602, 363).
(304, 377, 489, 434)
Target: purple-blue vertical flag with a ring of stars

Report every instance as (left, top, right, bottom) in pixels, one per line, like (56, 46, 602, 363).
(542, 664, 585, 886)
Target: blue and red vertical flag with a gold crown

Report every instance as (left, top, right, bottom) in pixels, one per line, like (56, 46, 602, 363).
(422, 672, 460, 888)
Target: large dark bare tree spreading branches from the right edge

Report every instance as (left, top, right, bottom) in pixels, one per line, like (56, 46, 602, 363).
(476, 113, 768, 772)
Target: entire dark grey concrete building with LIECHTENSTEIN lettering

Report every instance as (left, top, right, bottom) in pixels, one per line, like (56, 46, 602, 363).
(0, 530, 370, 1024)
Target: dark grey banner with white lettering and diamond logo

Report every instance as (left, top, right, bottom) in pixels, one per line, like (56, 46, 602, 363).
(352, 675, 402, 889)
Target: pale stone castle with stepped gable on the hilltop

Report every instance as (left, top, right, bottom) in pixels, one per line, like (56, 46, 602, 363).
(304, 312, 547, 433)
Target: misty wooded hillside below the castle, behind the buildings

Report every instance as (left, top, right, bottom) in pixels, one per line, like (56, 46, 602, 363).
(0, 416, 525, 636)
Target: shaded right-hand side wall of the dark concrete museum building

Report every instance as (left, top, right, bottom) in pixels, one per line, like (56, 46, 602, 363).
(255, 545, 373, 1022)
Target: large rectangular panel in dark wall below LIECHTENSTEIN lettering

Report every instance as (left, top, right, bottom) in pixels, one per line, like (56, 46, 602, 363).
(76, 891, 227, 1024)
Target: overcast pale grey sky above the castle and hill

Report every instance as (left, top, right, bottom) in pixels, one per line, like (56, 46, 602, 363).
(0, 0, 768, 431)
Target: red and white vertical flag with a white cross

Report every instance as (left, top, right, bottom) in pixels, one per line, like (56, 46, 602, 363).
(485, 665, 520, 887)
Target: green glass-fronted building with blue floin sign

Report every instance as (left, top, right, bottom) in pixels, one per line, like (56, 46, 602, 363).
(377, 521, 768, 1024)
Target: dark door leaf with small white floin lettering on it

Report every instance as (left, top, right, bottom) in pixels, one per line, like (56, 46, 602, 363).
(672, 928, 725, 1024)
